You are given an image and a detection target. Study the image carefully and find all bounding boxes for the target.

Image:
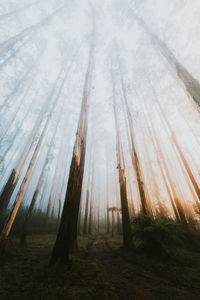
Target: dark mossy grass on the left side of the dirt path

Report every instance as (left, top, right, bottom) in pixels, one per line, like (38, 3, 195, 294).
(0, 235, 115, 300)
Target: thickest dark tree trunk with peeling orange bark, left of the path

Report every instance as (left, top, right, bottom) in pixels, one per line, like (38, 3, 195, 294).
(50, 43, 93, 264)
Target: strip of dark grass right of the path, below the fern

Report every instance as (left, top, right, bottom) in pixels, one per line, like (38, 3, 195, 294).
(105, 234, 200, 289)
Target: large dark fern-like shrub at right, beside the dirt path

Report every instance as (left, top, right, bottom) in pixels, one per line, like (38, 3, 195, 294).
(132, 214, 188, 257)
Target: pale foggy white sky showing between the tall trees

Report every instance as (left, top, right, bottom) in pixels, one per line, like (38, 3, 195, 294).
(0, 0, 200, 223)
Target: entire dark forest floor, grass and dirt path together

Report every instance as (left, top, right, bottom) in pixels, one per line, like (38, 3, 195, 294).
(0, 235, 200, 300)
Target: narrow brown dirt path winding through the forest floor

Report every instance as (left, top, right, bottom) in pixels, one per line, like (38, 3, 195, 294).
(90, 235, 200, 300)
